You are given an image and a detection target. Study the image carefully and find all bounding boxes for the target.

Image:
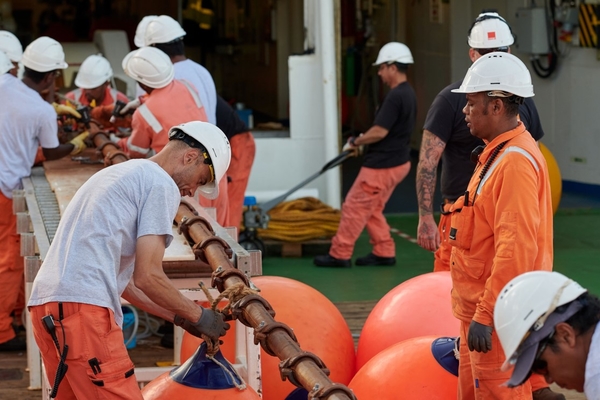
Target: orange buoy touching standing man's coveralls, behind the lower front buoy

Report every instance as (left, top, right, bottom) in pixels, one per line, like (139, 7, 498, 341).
(356, 271, 460, 370)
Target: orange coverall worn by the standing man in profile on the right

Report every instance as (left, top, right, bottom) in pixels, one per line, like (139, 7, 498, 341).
(449, 123, 553, 400)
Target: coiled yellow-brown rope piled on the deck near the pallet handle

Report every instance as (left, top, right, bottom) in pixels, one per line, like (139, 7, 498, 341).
(258, 197, 341, 242)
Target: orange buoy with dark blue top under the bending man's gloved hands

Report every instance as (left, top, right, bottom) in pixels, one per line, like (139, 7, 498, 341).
(142, 343, 260, 400)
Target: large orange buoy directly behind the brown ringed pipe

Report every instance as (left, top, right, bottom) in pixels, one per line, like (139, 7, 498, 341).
(252, 276, 355, 400)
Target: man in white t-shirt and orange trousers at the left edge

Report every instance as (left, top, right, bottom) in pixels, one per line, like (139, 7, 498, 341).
(0, 36, 85, 351)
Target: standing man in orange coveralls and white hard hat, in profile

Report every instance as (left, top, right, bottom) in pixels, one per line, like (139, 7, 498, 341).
(449, 52, 553, 400)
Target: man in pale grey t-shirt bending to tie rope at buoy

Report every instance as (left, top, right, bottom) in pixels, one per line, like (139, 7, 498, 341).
(28, 121, 231, 400)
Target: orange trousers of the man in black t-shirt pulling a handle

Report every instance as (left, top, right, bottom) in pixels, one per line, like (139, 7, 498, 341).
(329, 161, 410, 260)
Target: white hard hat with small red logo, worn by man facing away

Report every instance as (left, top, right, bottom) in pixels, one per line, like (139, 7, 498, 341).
(467, 12, 515, 49)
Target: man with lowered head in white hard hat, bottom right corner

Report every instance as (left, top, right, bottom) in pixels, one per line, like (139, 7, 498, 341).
(494, 271, 600, 400)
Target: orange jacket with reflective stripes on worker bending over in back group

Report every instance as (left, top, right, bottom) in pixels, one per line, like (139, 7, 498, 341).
(118, 80, 208, 158)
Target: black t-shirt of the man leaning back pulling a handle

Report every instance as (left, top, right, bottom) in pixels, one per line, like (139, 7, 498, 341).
(363, 82, 417, 169)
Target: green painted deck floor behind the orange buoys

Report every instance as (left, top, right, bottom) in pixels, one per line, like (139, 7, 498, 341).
(263, 209, 600, 302)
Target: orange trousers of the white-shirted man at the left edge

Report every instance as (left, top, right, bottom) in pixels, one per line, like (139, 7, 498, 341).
(0, 192, 25, 343)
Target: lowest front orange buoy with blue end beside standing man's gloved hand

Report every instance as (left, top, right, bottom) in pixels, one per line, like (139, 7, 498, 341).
(348, 336, 458, 400)
